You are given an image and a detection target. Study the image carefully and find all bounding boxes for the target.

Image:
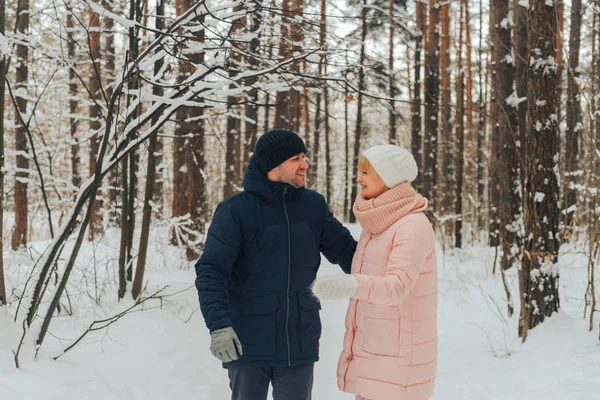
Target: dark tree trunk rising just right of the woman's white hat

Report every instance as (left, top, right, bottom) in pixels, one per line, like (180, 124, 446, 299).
(423, 0, 440, 212)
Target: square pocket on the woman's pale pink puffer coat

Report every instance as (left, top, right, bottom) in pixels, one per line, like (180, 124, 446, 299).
(363, 303, 400, 357)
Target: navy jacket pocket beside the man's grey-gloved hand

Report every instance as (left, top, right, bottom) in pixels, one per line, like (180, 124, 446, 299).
(233, 294, 279, 356)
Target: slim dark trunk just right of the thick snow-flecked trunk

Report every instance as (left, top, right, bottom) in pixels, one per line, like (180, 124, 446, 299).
(565, 0, 584, 240)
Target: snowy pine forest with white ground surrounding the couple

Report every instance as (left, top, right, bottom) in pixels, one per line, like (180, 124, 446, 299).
(0, 0, 600, 400)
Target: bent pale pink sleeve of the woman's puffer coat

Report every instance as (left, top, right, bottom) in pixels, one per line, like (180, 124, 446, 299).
(354, 217, 435, 305)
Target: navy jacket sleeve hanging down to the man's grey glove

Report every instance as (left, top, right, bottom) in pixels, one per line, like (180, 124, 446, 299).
(196, 203, 242, 333)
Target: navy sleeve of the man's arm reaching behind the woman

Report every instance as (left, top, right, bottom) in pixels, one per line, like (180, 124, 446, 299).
(319, 204, 356, 274)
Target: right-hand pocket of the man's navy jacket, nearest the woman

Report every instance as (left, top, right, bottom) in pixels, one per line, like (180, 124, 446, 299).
(298, 292, 321, 357)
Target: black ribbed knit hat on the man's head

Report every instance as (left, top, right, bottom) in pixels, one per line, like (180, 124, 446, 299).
(254, 129, 306, 175)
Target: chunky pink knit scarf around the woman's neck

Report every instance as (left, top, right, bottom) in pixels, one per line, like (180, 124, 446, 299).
(352, 182, 427, 234)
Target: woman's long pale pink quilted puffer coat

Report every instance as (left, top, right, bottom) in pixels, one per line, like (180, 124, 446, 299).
(337, 184, 437, 400)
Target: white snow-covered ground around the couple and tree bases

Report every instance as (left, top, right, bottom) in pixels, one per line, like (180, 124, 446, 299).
(0, 226, 600, 400)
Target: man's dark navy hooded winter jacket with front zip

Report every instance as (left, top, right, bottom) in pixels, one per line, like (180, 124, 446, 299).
(196, 155, 356, 367)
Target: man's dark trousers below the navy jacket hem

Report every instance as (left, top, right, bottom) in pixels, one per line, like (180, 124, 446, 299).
(227, 363, 315, 400)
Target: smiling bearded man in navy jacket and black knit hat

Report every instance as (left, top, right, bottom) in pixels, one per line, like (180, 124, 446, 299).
(196, 130, 356, 400)
